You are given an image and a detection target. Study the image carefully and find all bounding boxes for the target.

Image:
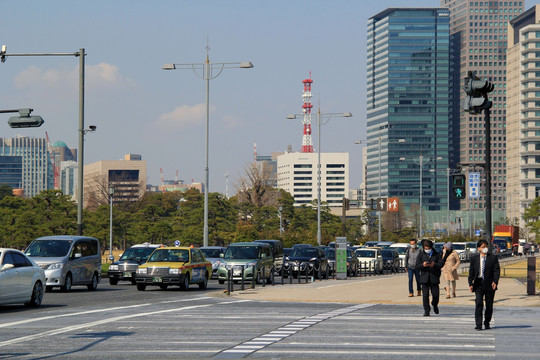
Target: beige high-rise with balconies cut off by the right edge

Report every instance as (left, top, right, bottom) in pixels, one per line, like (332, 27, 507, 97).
(506, 5, 540, 226)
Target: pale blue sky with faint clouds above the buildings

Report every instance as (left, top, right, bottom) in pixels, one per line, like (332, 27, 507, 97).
(0, 0, 536, 195)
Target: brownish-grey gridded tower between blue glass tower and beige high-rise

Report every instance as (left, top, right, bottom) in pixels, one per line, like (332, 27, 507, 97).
(440, 0, 524, 210)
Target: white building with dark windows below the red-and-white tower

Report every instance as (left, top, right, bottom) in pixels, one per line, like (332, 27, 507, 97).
(277, 152, 349, 207)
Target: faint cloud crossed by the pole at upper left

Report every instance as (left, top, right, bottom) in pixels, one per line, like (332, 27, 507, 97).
(14, 63, 136, 92)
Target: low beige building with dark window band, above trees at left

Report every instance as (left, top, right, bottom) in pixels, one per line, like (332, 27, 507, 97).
(84, 154, 146, 208)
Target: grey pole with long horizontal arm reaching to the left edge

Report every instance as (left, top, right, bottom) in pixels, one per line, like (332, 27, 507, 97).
(0, 45, 86, 236)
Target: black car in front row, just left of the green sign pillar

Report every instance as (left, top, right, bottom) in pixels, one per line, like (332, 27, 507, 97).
(284, 246, 328, 279)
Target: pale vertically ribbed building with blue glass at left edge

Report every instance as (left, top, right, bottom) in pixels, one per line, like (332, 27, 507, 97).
(0, 136, 53, 197)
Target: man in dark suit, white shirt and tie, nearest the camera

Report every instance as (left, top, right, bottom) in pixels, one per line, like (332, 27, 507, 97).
(469, 240, 501, 330)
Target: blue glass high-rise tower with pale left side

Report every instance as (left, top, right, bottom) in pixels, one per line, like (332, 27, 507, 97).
(365, 8, 449, 212)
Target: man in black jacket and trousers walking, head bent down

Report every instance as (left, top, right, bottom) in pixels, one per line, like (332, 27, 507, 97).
(416, 240, 443, 316)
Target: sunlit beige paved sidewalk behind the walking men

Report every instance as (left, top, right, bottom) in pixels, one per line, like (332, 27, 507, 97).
(219, 274, 540, 307)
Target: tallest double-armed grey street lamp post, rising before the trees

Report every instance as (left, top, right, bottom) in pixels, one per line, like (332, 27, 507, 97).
(162, 47, 253, 246)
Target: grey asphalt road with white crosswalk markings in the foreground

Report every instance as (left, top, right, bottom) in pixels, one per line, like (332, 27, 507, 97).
(0, 281, 540, 360)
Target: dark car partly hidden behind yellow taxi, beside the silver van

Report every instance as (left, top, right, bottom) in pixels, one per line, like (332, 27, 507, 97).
(107, 243, 162, 285)
